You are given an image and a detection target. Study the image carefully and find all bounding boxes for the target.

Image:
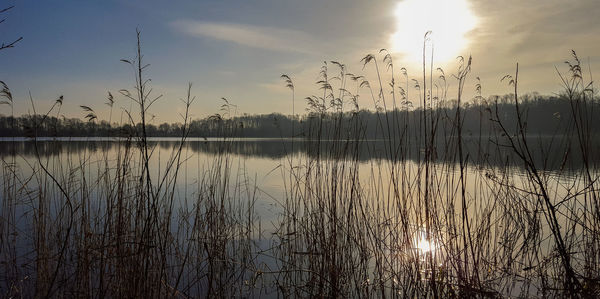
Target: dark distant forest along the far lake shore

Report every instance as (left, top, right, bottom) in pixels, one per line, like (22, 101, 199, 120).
(0, 93, 600, 139)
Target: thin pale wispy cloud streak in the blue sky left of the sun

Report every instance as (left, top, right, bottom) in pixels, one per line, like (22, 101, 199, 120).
(171, 20, 315, 53)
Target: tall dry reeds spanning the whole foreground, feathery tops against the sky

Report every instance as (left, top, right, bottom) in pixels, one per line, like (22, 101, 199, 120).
(0, 32, 600, 298)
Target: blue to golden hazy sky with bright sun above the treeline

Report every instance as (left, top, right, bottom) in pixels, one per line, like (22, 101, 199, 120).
(0, 0, 600, 123)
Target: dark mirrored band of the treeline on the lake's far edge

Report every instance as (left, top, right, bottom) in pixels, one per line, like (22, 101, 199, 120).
(0, 138, 600, 170)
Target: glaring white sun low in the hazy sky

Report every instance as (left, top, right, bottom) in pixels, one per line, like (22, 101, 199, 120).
(391, 0, 477, 63)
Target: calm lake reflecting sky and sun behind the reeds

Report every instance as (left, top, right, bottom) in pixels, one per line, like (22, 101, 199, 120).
(0, 137, 600, 297)
